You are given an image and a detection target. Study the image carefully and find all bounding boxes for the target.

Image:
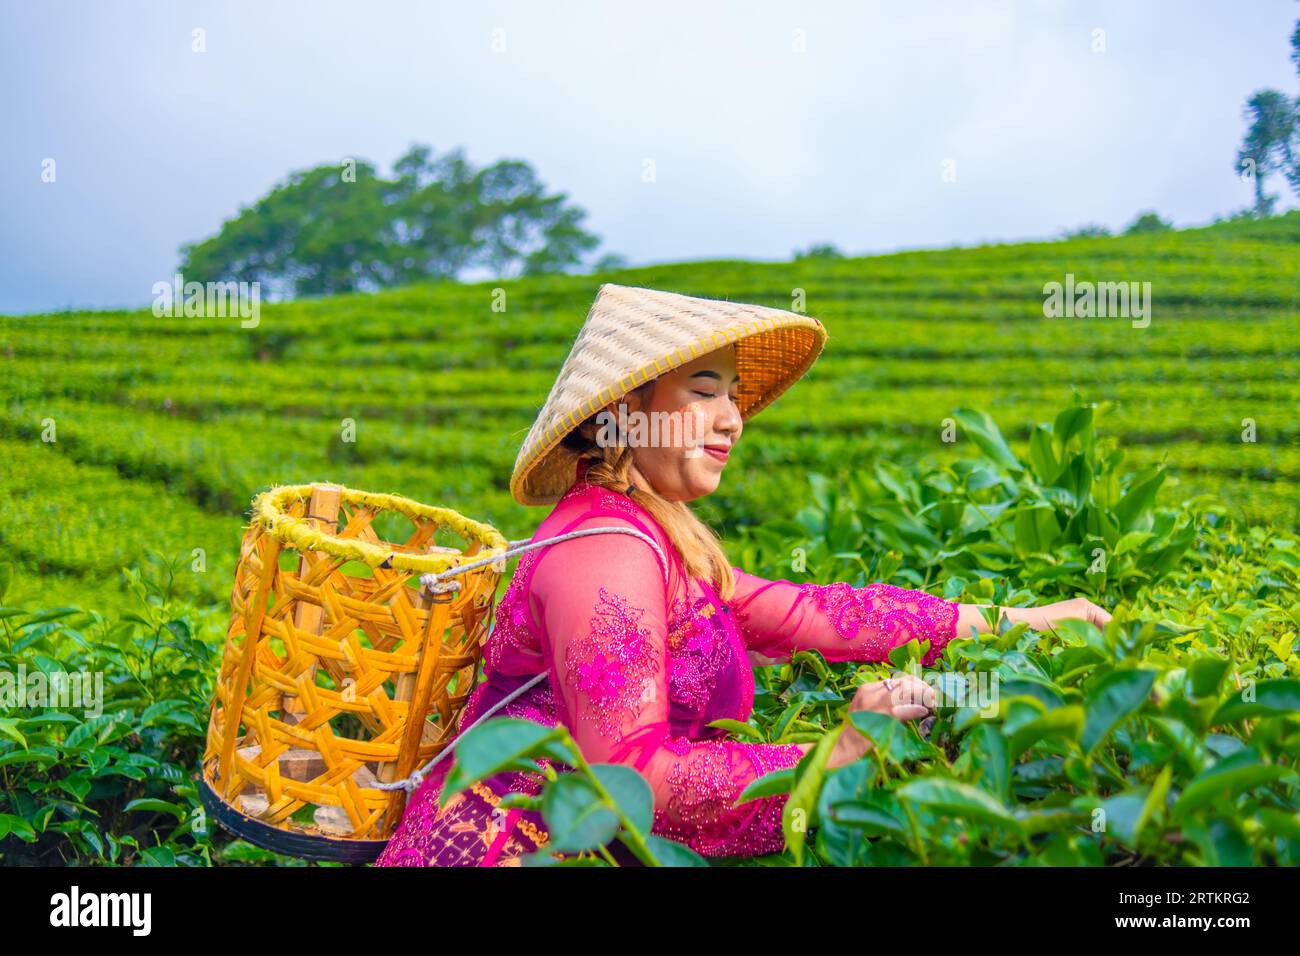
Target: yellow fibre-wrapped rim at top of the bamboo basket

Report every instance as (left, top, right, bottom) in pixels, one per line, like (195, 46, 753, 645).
(252, 481, 510, 574)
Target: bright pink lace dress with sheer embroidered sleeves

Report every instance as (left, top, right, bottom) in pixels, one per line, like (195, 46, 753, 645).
(377, 467, 958, 866)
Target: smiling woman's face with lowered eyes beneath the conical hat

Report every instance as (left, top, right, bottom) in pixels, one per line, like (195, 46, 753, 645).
(607, 345, 744, 501)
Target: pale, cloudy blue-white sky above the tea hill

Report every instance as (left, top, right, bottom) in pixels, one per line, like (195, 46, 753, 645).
(0, 0, 1300, 312)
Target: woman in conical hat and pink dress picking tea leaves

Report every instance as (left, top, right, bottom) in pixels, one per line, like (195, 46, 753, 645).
(377, 285, 1109, 866)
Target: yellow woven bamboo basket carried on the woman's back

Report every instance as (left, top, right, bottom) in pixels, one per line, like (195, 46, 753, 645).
(200, 484, 507, 862)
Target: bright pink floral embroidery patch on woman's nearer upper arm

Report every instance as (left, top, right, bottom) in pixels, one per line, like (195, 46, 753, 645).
(564, 587, 659, 740)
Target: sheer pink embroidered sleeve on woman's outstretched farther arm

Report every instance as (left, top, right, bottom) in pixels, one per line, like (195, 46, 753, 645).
(731, 568, 959, 666)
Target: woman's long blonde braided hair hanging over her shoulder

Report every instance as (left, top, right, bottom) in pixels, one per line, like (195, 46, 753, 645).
(563, 381, 736, 601)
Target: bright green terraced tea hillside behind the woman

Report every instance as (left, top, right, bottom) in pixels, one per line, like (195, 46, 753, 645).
(0, 212, 1300, 607)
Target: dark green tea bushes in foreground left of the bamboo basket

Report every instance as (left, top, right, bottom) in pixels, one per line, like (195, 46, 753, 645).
(0, 554, 300, 866)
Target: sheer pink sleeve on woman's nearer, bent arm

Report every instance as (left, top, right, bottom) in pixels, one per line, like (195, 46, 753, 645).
(533, 515, 803, 856)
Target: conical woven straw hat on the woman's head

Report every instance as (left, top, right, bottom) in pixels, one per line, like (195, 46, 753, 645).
(510, 282, 827, 505)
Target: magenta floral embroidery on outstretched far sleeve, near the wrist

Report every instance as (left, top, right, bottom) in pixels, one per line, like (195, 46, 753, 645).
(798, 581, 959, 665)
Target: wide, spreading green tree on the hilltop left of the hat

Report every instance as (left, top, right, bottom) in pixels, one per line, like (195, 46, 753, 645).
(181, 146, 599, 295)
